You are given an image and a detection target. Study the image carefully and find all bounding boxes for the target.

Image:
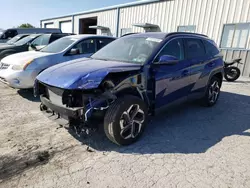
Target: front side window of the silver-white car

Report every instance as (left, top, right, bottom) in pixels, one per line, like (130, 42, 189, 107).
(73, 39, 96, 54)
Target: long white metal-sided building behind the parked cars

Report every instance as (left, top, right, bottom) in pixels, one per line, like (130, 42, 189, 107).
(41, 0, 250, 77)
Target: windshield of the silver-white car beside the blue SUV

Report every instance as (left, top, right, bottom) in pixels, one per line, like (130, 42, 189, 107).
(40, 37, 77, 53)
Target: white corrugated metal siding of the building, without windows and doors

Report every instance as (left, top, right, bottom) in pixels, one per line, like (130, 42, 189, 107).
(42, 0, 250, 76)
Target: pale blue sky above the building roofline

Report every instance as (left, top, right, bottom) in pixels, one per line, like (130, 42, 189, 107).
(0, 0, 136, 29)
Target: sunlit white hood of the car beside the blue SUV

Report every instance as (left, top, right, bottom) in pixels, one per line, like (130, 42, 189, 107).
(1, 51, 53, 65)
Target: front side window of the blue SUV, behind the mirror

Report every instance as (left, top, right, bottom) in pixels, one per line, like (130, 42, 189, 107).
(156, 39, 184, 61)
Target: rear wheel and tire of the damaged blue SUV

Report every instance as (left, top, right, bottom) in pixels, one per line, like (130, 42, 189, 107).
(201, 76, 222, 107)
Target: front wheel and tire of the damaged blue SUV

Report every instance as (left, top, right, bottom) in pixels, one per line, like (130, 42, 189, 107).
(104, 95, 148, 145)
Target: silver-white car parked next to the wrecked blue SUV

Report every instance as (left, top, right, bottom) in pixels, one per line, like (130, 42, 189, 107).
(0, 35, 115, 89)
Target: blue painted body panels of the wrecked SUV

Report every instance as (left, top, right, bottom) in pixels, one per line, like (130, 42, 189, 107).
(37, 33, 224, 110)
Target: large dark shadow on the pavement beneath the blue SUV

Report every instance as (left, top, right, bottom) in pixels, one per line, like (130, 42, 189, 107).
(67, 92, 250, 154)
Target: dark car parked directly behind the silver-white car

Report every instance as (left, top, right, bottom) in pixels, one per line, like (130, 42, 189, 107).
(0, 33, 70, 60)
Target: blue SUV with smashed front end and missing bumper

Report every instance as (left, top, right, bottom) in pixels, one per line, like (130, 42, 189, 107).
(35, 33, 223, 145)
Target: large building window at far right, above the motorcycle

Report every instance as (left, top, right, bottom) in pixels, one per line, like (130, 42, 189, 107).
(220, 23, 250, 48)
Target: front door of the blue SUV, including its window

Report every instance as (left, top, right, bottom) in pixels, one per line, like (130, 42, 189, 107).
(153, 39, 191, 108)
